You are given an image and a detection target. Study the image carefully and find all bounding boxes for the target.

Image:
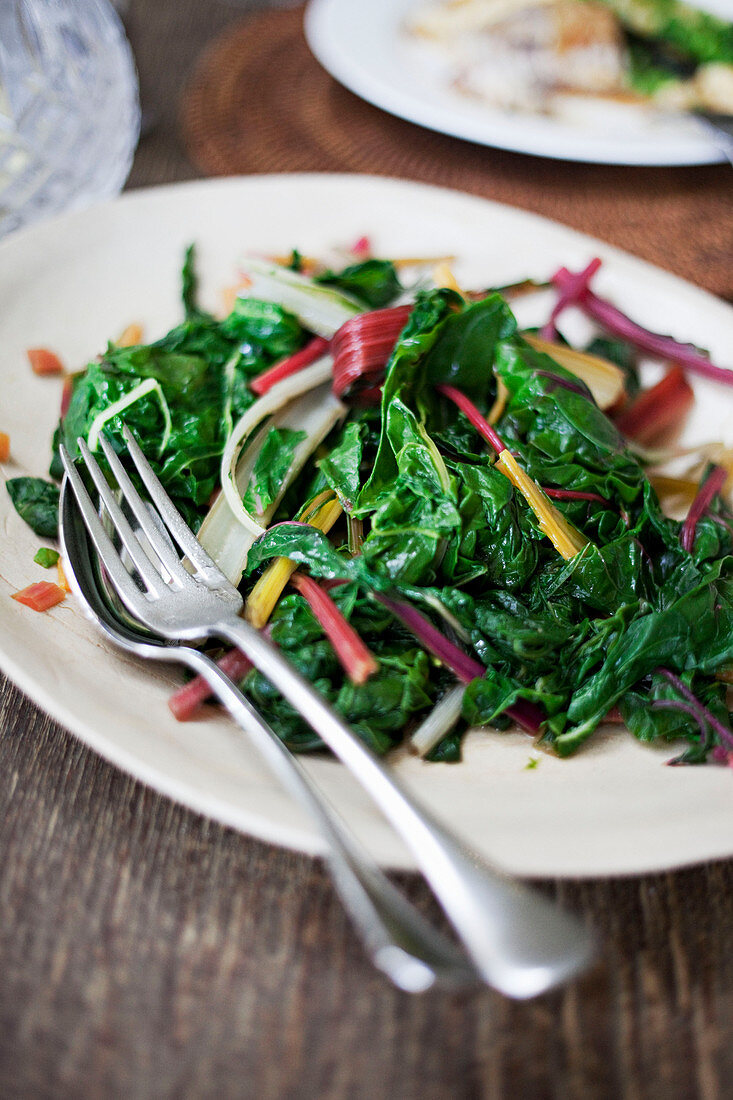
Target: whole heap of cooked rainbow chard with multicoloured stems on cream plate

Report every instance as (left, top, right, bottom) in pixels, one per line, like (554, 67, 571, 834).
(32, 245, 733, 763)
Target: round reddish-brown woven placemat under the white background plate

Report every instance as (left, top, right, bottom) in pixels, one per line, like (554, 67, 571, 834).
(182, 9, 733, 300)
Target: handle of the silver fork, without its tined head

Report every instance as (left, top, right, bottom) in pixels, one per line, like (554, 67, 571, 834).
(208, 616, 594, 998)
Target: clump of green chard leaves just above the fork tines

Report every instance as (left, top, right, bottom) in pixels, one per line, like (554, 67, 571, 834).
(57, 279, 305, 529)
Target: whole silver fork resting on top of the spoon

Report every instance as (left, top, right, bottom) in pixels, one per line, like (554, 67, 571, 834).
(62, 428, 594, 998)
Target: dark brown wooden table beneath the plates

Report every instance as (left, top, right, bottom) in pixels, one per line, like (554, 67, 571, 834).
(0, 0, 733, 1100)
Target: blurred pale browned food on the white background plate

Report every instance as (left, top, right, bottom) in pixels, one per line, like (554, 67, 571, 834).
(407, 0, 733, 113)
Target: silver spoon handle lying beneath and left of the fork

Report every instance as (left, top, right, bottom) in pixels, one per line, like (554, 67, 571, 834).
(172, 647, 479, 993)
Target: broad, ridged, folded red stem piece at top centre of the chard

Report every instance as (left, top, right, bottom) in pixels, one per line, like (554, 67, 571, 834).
(331, 305, 413, 397)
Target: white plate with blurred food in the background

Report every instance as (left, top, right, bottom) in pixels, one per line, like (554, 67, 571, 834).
(305, 0, 725, 165)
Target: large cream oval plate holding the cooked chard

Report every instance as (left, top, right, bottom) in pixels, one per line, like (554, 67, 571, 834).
(0, 175, 733, 876)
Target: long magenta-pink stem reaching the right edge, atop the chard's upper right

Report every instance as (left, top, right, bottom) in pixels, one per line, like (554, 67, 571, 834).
(553, 267, 733, 386)
